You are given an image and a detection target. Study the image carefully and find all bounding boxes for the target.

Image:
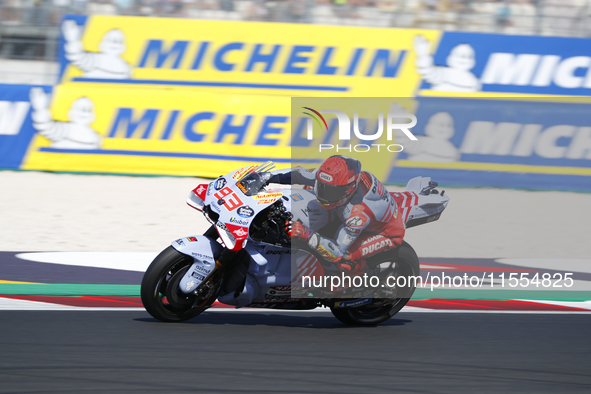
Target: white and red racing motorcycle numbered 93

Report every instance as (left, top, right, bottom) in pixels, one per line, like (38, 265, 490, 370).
(141, 162, 449, 325)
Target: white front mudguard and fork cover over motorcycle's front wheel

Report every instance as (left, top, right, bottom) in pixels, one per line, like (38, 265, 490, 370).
(172, 235, 223, 294)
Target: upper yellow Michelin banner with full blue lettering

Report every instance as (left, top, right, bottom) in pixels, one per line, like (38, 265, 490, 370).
(59, 15, 441, 97)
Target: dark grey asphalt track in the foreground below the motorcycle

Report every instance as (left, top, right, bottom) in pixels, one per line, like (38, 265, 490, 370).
(0, 311, 591, 393)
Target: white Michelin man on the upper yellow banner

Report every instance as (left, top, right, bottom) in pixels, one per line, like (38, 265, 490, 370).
(62, 20, 133, 79)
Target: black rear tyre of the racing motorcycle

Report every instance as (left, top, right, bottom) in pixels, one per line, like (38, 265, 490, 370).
(331, 242, 420, 326)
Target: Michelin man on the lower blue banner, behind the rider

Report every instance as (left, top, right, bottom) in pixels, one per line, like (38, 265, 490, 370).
(404, 112, 460, 163)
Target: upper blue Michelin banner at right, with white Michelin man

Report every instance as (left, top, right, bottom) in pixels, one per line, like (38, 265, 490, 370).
(414, 32, 591, 96)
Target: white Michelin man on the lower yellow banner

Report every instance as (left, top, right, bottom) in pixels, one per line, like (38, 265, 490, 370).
(30, 88, 101, 149)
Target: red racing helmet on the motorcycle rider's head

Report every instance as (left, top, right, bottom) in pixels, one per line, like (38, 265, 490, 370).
(314, 156, 361, 209)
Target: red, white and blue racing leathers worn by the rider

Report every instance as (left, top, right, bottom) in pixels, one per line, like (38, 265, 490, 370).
(270, 167, 405, 275)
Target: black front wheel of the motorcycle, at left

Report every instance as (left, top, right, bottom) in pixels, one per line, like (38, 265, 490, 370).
(141, 246, 216, 322)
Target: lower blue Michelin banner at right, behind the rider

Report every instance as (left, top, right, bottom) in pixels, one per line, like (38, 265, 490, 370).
(388, 97, 591, 191)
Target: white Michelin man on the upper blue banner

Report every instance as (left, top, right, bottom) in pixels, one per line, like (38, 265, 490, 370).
(414, 35, 481, 92)
